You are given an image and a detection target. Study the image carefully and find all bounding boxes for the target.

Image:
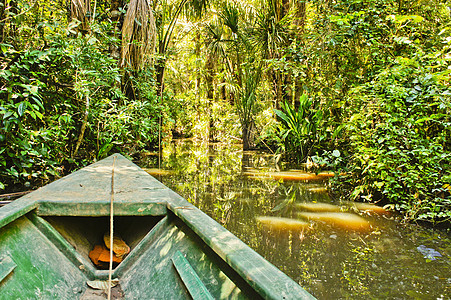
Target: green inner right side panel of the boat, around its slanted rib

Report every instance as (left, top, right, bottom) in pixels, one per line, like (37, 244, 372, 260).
(119, 214, 251, 300)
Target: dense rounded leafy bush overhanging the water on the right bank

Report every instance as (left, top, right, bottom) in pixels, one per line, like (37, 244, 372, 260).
(340, 52, 451, 222)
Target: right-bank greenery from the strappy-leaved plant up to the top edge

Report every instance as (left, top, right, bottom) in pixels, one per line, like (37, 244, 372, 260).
(254, 1, 451, 223)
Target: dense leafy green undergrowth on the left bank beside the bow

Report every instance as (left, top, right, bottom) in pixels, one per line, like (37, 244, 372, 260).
(0, 12, 161, 191)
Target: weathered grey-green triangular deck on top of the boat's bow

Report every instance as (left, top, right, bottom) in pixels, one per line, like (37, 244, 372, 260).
(16, 154, 169, 205)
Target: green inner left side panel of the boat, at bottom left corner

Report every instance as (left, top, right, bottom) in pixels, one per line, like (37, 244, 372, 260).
(0, 216, 88, 300)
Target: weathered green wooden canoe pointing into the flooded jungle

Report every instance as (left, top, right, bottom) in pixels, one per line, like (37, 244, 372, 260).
(0, 154, 314, 299)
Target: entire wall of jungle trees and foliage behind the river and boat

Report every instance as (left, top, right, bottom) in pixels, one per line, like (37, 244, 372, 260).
(0, 0, 451, 222)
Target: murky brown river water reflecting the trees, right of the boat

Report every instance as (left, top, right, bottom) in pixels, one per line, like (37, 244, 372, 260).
(139, 140, 451, 299)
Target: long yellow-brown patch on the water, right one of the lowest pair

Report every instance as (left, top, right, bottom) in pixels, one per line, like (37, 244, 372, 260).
(298, 212, 371, 230)
